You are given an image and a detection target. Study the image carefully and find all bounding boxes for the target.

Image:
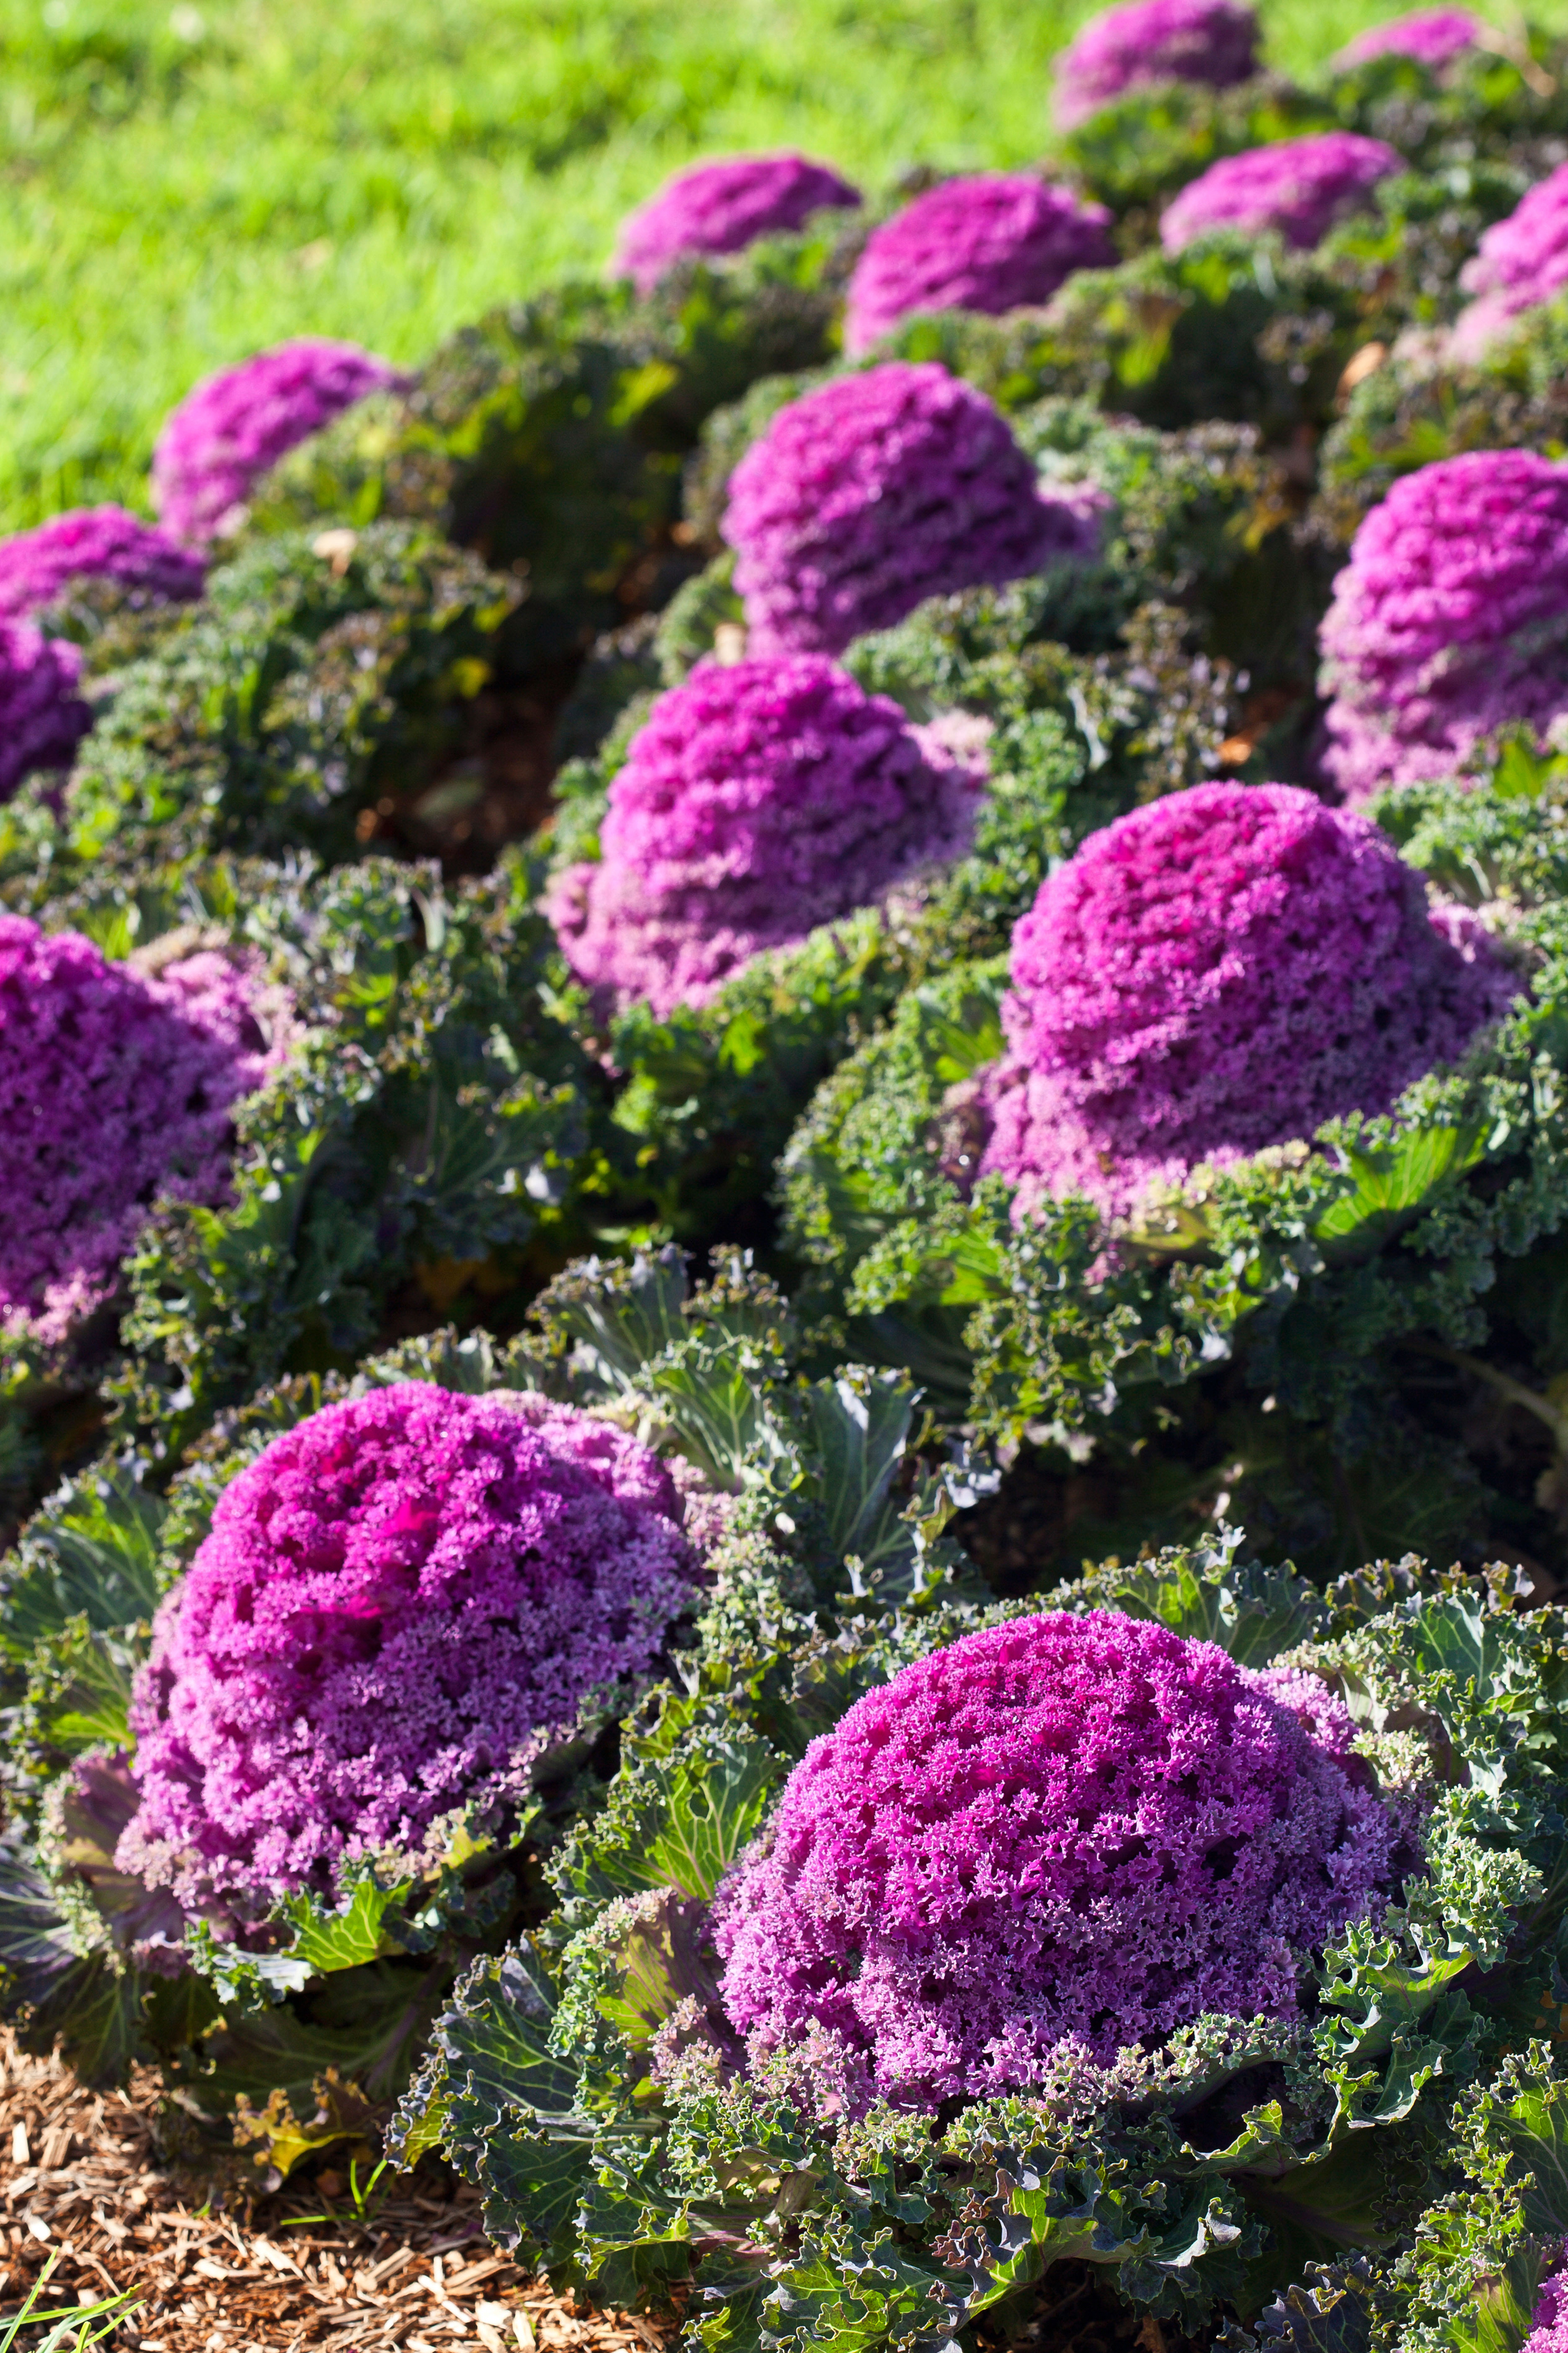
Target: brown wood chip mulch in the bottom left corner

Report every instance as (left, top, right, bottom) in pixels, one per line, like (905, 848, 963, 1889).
(0, 2028, 671, 2353)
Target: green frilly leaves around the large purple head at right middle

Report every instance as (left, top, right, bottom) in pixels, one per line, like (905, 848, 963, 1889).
(782, 772, 1568, 1574)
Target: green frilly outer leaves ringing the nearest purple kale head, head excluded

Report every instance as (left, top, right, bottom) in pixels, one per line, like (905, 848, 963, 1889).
(400, 1537, 1568, 2353)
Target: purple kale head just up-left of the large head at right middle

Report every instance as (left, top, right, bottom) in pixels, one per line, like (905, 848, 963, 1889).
(551, 654, 977, 1017)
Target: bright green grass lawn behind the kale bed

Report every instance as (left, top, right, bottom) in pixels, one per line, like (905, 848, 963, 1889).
(0, 0, 1534, 529)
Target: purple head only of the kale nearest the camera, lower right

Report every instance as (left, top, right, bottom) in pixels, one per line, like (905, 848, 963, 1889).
(716, 1609, 1396, 2106)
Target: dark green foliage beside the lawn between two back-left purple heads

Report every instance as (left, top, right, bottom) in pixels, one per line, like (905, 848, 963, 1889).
(254, 221, 864, 670)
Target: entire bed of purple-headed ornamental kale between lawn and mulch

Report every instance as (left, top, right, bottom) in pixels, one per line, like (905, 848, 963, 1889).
(0, 0, 1568, 2353)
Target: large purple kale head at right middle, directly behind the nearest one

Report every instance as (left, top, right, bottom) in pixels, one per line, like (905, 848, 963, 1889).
(982, 783, 1516, 1214)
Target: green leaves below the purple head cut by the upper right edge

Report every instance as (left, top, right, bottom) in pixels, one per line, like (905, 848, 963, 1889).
(1311, 299, 1568, 546)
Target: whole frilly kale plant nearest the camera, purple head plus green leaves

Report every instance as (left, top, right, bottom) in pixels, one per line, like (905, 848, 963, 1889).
(403, 1537, 1566, 2353)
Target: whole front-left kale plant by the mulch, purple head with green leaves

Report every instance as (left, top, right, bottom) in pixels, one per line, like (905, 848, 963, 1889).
(0, 1249, 975, 2172)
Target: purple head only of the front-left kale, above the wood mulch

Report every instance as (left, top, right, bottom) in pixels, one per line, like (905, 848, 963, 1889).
(118, 1381, 695, 1910)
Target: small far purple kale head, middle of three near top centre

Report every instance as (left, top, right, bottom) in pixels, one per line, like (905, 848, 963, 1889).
(843, 172, 1116, 353)
